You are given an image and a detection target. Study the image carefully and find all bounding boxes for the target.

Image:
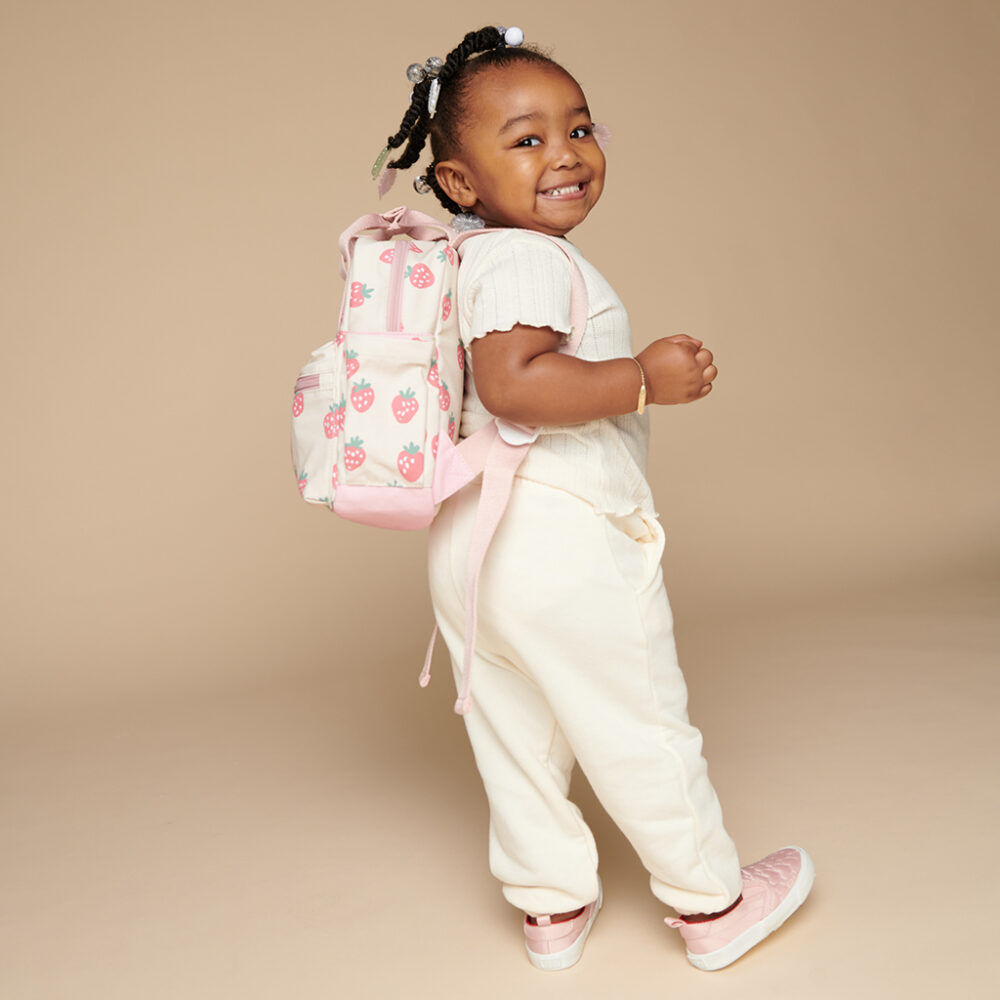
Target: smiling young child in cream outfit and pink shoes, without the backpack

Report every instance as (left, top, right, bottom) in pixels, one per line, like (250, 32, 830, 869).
(378, 27, 813, 969)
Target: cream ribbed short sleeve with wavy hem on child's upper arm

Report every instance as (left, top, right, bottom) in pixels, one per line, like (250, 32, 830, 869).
(458, 230, 572, 345)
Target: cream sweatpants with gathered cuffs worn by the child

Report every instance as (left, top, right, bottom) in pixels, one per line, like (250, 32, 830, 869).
(429, 478, 741, 916)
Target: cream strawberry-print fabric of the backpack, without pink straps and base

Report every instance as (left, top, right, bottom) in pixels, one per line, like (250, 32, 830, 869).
(292, 230, 465, 507)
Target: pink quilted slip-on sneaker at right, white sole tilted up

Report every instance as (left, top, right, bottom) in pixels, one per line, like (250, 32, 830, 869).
(666, 847, 815, 972)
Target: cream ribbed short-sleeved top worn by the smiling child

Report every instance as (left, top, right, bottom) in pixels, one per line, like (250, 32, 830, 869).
(458, 229, 654, 515)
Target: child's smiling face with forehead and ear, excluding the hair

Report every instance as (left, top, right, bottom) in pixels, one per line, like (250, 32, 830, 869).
(438, 63, 605, 236)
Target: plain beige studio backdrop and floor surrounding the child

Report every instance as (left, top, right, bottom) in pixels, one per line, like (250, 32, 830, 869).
(0, 0, 1000, 1000)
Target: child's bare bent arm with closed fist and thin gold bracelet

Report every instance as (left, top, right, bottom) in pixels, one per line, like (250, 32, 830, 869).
(471, 326, 718, 427)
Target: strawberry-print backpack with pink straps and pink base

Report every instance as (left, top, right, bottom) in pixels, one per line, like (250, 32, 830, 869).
(292, 206, 587, 713)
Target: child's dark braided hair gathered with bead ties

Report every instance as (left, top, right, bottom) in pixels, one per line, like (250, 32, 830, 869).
(386, 25, 565, 215)
